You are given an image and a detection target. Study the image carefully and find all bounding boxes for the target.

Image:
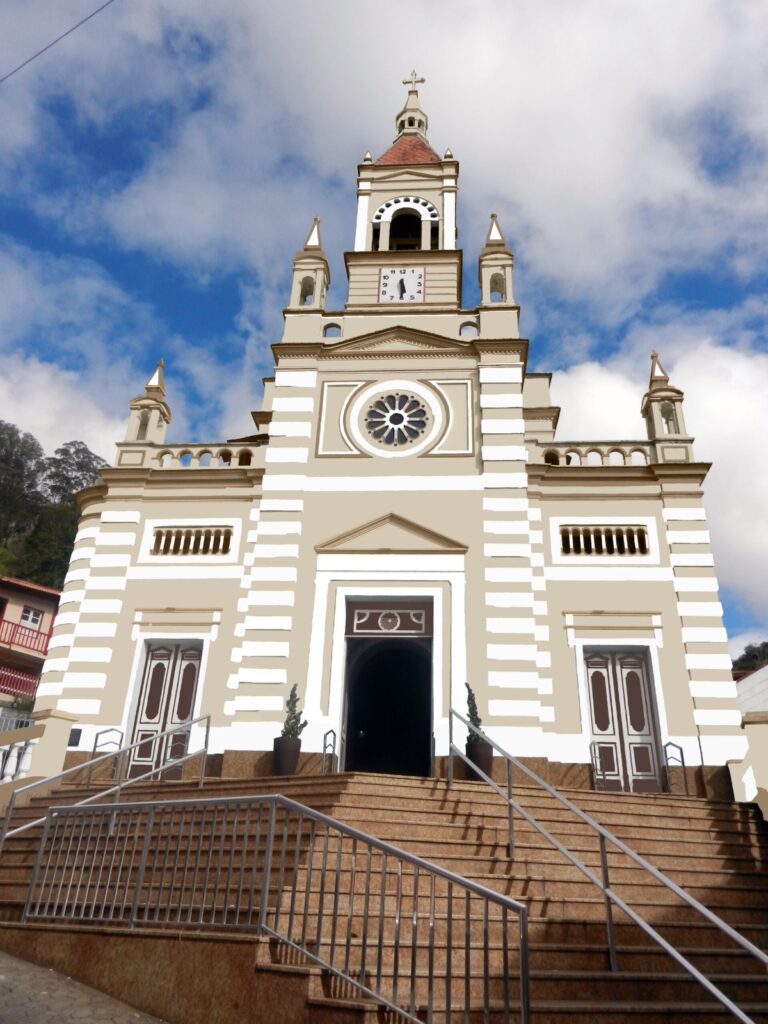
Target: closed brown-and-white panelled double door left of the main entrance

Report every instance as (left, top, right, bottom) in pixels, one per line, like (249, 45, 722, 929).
(128, 643, 203, 778)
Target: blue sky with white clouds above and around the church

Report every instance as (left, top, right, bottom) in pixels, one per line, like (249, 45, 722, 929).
(0, 0, 768, 650)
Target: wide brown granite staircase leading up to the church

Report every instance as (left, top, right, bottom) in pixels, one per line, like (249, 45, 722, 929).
(0, 774, 768, 1024)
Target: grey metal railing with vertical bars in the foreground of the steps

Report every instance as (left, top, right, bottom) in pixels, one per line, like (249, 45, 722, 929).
(23, 795, 530, 1024)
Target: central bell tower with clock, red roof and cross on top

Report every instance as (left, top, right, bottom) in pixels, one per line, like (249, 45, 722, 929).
(345, 72, 461, 312)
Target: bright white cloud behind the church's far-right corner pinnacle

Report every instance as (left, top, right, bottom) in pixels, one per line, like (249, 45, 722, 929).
(552, 315, 768, 628)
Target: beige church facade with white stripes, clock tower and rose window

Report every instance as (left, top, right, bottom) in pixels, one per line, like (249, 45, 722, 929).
(38, 75, 744, 792)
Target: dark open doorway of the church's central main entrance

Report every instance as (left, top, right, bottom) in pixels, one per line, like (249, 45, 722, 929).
(344, 637, 432, 775)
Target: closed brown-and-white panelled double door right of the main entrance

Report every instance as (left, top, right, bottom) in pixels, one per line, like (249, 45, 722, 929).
(585, 650, 662, 793)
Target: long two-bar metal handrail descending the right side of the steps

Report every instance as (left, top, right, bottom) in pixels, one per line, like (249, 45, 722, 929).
(447, 708, 768, 1024)
